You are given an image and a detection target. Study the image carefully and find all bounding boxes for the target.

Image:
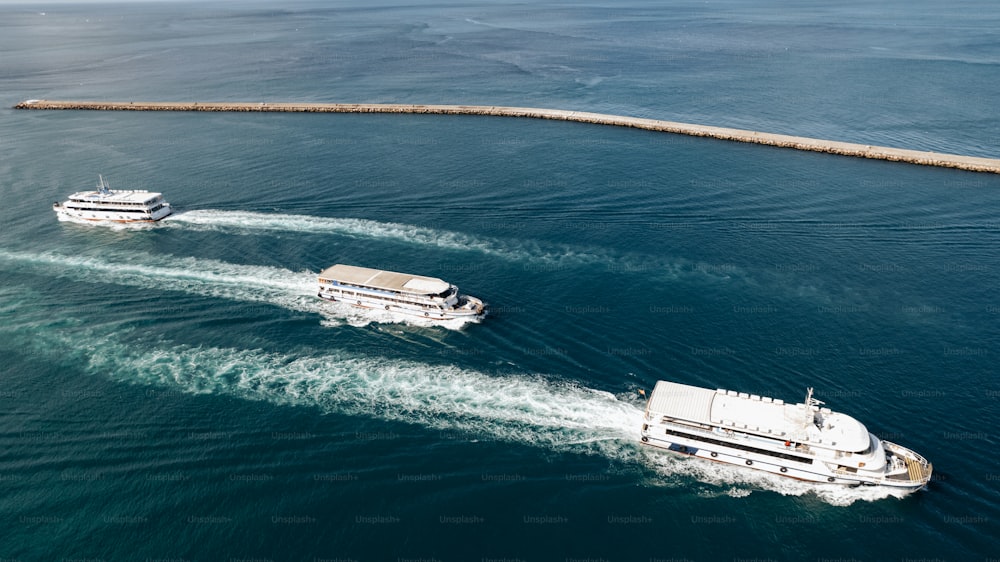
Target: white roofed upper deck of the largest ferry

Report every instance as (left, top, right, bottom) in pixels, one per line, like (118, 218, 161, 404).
(648, 381, 871, 452)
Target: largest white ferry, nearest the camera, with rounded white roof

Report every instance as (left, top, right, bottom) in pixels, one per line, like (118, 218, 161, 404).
(641, 381, 933, 491)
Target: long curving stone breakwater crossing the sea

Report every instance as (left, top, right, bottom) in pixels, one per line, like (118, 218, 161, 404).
(14, 100, 1000, 174)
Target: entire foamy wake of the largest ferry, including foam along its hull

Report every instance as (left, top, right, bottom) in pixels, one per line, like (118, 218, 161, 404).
(0, 282, 896, 505)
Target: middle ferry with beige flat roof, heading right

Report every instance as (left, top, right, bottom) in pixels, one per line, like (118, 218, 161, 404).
(319, 264, 486, 320)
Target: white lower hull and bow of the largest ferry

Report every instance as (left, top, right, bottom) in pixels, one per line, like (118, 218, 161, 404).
(642, 424, 931, 490)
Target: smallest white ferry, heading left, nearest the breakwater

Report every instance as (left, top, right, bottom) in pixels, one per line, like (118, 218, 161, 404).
(52, 175, 173, 222)
